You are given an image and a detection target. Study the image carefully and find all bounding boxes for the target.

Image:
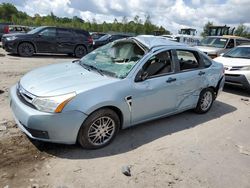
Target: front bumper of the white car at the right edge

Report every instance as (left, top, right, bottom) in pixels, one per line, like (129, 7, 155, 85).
(225, 73, 250, 89)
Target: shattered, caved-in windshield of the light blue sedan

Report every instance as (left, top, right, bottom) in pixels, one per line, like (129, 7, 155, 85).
(80, 40, 144, 79)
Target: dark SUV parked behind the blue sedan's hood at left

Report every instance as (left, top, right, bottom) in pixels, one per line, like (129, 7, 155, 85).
(2, 26, 93, 58)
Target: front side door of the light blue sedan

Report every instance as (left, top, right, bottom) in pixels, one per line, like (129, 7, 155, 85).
(131, 51, 177, 124)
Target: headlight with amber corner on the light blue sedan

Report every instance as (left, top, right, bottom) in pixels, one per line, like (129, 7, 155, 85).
(32, 92, 76, 113)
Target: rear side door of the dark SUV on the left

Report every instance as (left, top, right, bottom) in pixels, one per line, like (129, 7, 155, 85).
(56, 28, 76, 53)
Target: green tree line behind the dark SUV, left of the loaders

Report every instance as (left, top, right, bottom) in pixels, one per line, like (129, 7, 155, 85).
(0, 3, 170, 34)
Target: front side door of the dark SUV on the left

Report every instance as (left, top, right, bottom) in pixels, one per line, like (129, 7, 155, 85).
(34, 28, 57, 53)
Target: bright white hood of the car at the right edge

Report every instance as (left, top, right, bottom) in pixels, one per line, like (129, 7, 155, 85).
(213, 56, 250, 67)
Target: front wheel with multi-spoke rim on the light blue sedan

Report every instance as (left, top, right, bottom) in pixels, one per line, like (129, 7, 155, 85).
(77, 108, 120, 149)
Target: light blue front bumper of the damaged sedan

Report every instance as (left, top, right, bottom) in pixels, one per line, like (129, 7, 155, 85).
(10, 86, 87, 144)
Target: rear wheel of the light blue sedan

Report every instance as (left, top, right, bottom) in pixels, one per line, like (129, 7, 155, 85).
(194, 88, 215, 114)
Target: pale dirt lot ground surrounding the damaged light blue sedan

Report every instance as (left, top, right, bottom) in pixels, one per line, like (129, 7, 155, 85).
(0, 46, 250, 188)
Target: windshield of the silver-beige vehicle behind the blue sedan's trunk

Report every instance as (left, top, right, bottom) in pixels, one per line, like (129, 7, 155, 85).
(201, 37, 228, 48)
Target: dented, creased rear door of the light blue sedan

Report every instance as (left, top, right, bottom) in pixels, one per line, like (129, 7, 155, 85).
(174, 49, 208, 110)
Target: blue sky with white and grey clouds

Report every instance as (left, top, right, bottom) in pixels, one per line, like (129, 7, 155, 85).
(0, 0, 250, 34)
